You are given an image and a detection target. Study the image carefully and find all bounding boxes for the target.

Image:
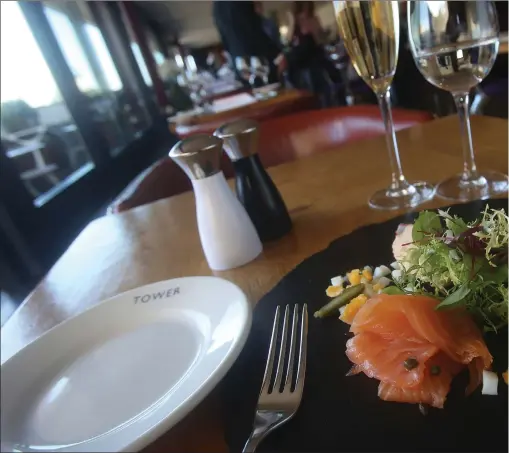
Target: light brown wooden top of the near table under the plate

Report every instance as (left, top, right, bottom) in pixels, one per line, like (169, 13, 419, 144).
(1, 116, 508, 452)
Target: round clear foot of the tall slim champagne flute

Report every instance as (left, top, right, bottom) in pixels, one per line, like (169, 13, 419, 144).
(369, 182, 435, 211)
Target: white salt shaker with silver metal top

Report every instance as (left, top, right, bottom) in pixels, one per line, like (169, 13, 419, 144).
(169, 135, 262, 271)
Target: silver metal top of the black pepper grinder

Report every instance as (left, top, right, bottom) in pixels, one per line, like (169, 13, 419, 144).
(214, 119, 258, 162)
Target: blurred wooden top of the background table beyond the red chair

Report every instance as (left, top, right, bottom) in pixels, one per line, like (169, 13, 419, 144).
(170, 89, 313, 137)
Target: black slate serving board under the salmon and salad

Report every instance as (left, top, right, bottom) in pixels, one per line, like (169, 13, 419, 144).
(221, 200, 508, 452)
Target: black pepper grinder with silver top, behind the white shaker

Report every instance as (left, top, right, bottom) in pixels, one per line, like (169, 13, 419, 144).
(214, 119, 292, 242)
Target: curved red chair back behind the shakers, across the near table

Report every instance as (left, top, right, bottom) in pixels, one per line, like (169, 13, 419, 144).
(108, 105, 433, 213)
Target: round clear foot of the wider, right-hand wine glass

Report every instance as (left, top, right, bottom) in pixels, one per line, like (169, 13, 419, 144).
(437, 171, 509, 201)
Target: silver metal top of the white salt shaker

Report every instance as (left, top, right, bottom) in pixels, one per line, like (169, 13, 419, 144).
(169, 135, 223, 179)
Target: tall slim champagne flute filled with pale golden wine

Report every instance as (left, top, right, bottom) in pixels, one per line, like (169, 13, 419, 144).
(334, 0, 435, 210)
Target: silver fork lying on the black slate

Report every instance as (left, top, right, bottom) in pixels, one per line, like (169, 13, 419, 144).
(242, 304, 308, 453)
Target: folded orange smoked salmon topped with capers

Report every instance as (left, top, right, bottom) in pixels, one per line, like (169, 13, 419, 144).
(346, 294, 493, 408)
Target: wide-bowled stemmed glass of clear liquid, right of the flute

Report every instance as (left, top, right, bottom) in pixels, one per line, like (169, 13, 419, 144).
(407, 1, 508, 201)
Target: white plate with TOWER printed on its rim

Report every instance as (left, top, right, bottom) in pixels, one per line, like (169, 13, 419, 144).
(0, 277, 251, 453)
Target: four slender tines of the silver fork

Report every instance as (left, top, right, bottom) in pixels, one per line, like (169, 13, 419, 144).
(260, 304, 308, 394)
